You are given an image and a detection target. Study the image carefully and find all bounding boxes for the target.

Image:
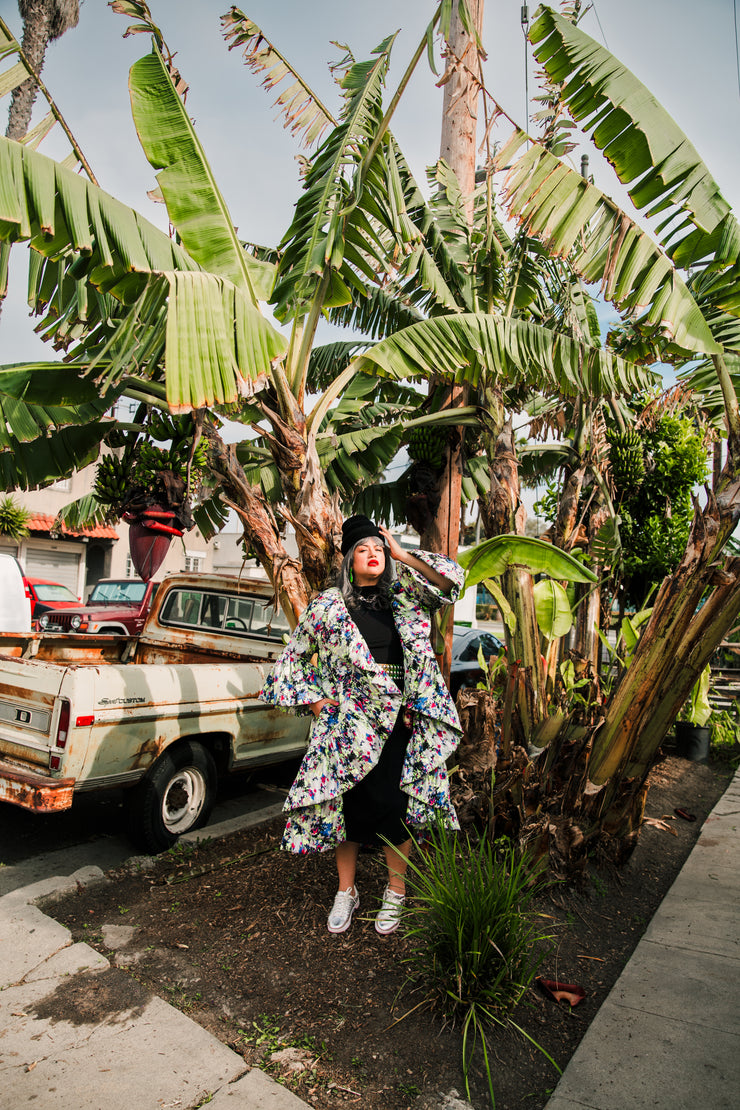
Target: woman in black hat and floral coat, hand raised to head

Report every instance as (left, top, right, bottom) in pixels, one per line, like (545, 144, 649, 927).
(261, 516, 464, 935)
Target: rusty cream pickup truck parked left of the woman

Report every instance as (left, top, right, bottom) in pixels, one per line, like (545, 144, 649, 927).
(0, 574, 308, 851)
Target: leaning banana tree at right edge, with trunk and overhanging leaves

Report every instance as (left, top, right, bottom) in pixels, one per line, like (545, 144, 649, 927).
(448, 8, 740, 857)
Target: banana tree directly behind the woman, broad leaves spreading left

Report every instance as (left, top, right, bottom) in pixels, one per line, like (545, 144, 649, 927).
(0, 2, 452, 619)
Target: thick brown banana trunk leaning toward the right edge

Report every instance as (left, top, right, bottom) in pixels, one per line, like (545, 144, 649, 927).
(483, 468, 740, 874)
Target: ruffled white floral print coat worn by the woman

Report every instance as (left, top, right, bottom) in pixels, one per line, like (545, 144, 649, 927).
(260, 552, 464, 854)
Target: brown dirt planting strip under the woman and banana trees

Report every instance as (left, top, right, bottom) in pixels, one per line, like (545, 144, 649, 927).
(47, 755, 731, 1110)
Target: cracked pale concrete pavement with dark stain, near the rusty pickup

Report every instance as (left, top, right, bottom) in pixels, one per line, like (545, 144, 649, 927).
(0, 805, 306, 1110)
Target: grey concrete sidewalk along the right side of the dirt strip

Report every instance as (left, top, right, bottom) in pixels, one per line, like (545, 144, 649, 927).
(546, 771, 740, 1110)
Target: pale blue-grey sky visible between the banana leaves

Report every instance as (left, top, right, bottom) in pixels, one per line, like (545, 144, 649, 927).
(0, 0, 740, 363)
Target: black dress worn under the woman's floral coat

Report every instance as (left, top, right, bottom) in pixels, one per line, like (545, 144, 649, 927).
(343, 588, 412, 847)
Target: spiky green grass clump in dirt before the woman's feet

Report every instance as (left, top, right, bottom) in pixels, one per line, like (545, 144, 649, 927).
(403, 826, 559, 1106)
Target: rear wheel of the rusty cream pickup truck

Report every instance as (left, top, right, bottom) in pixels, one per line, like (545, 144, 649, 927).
(128, 740, 216, 852)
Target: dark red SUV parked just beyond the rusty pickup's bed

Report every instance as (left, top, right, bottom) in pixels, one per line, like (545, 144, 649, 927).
(38, 578, 159, 636)
